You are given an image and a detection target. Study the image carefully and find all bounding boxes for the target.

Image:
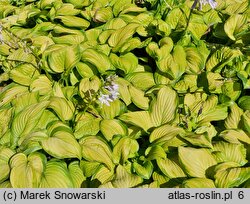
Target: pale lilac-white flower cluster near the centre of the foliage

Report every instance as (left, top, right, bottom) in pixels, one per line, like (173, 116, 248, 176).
(98, 75, 119, 106)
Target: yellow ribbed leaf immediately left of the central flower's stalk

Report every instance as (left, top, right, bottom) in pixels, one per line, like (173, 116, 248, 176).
(48, 96, 75, 121)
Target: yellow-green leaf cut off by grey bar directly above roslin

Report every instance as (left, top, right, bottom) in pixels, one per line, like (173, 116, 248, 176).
(182, 178, 215, 188)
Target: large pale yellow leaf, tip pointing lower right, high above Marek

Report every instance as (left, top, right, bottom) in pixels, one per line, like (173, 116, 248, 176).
(41, 127, 81, 159)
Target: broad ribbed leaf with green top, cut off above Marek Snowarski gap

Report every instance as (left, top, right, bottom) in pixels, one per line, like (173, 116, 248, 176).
(39, 160, 74, 188)
